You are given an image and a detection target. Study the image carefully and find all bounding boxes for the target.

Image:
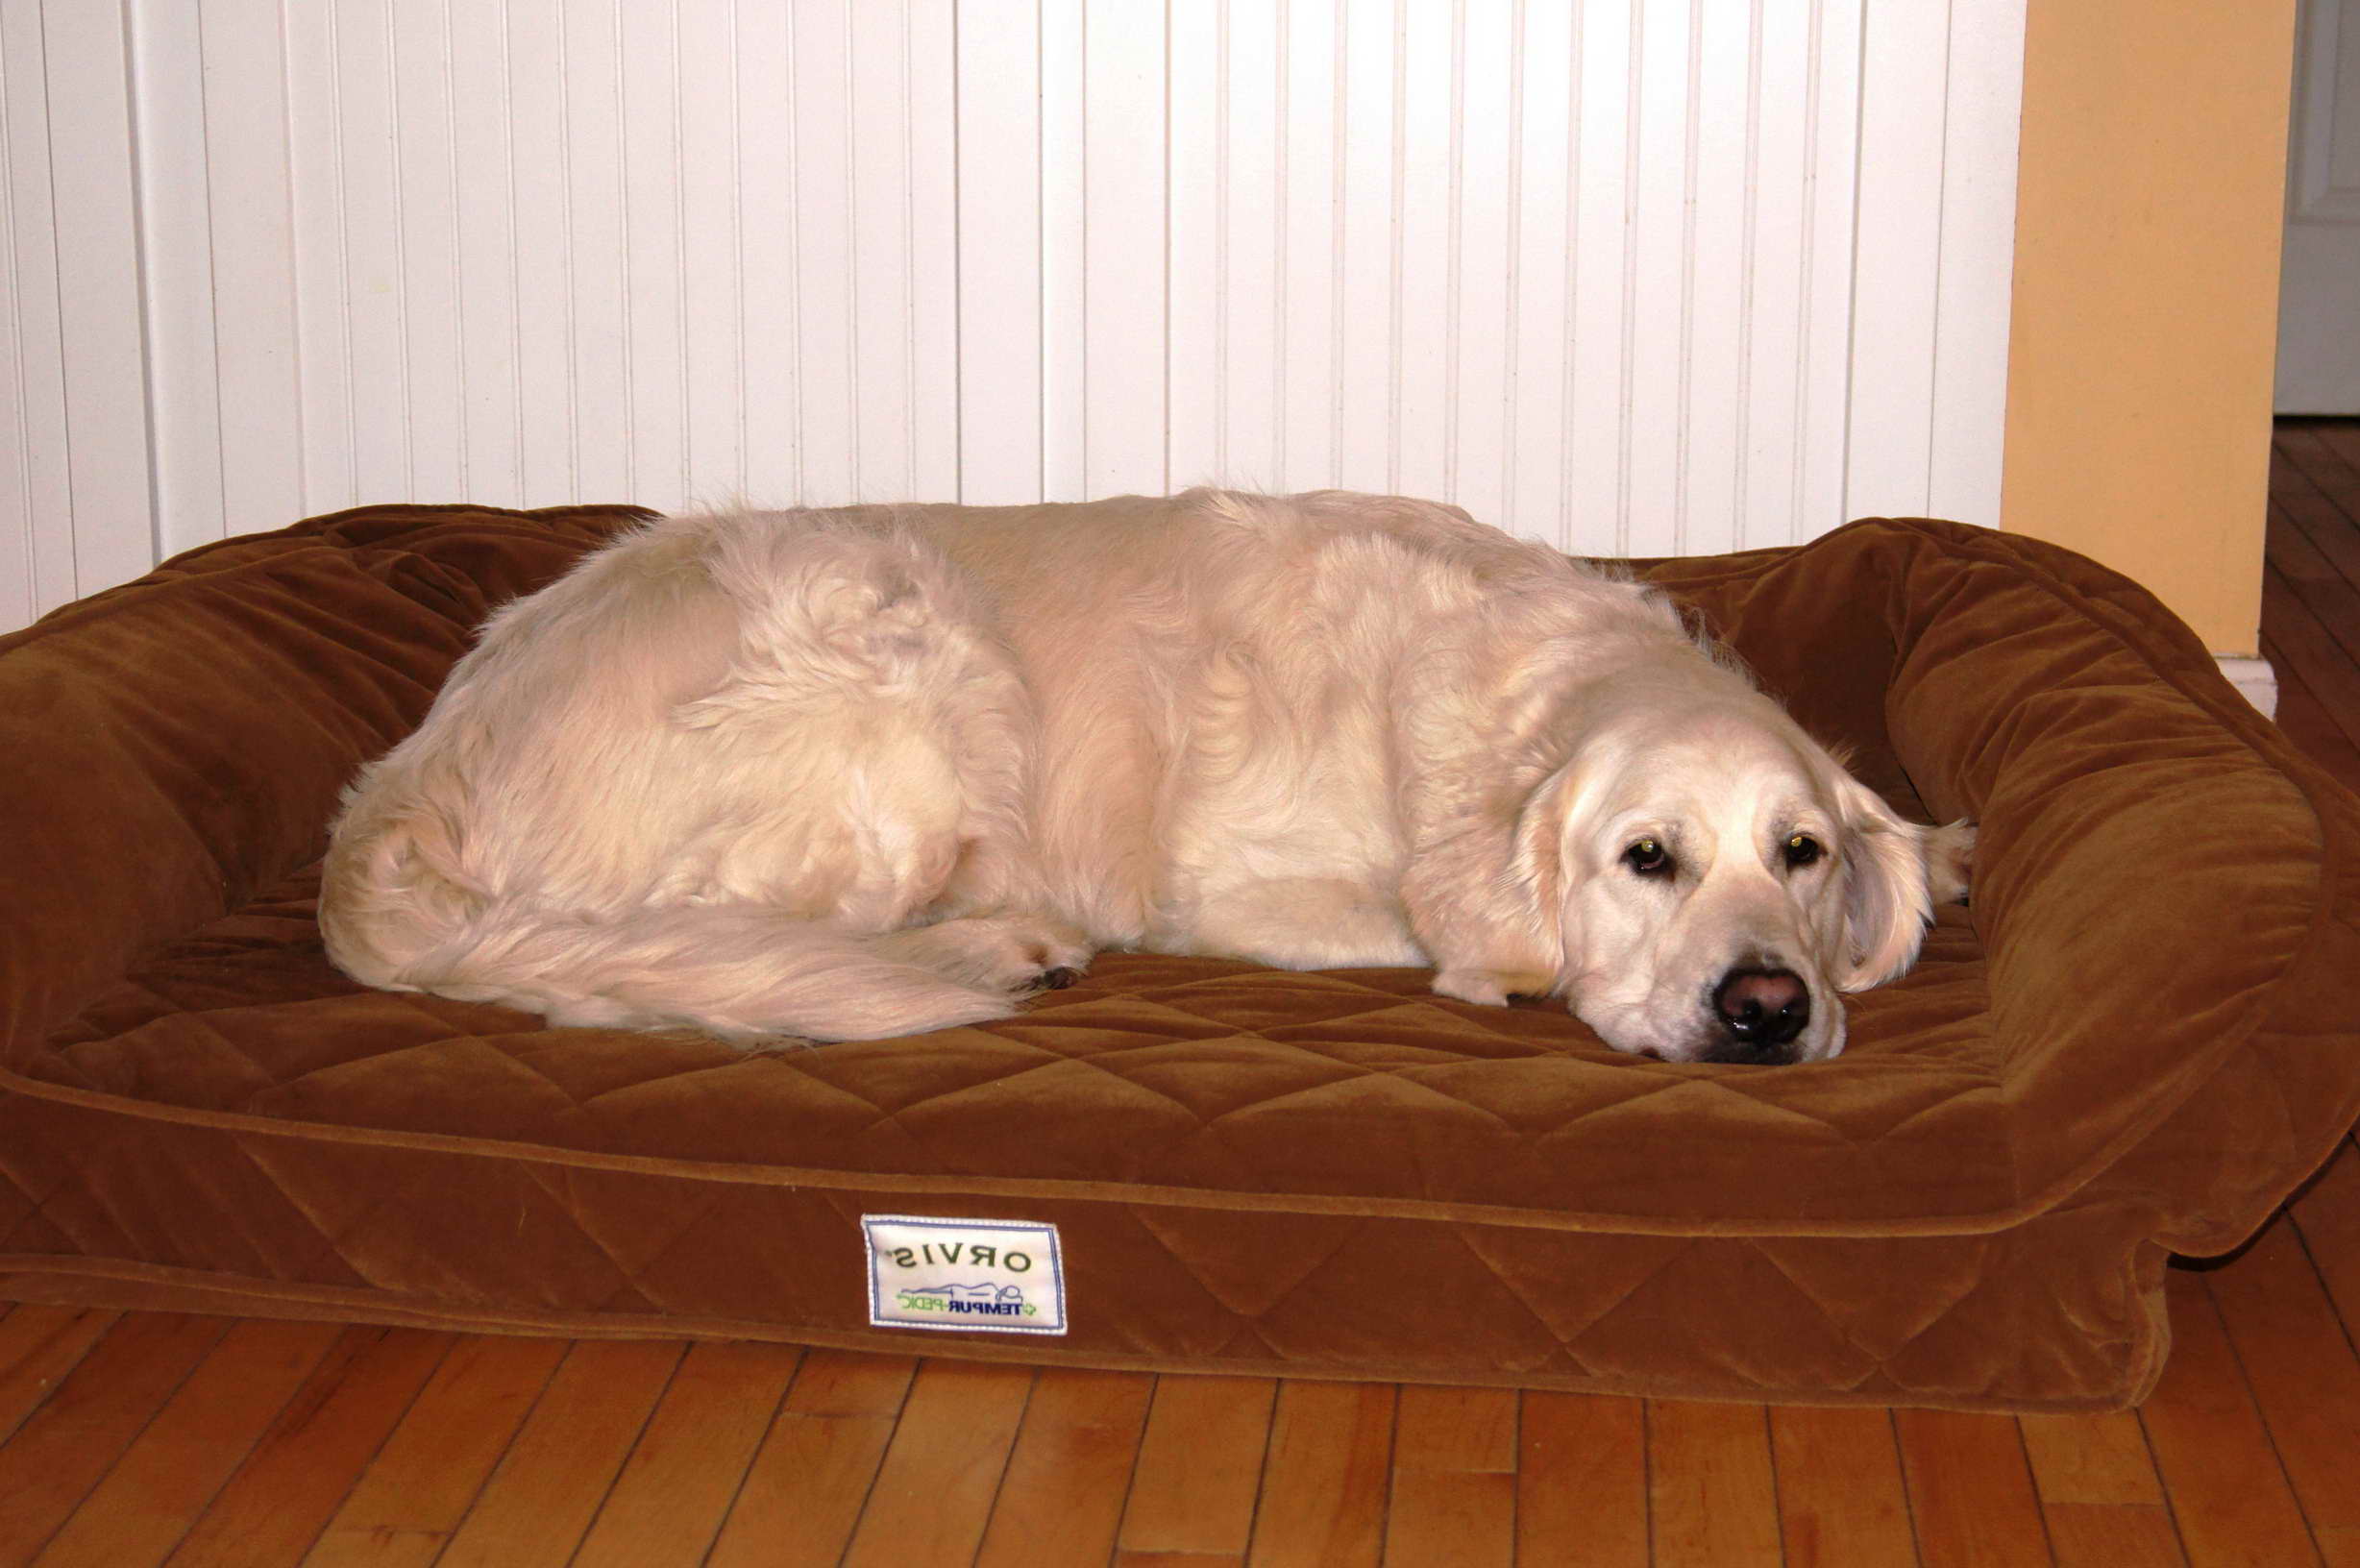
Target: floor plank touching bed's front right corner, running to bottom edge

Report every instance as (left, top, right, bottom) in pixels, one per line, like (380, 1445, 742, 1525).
(2138, 1270, 2318, 1568)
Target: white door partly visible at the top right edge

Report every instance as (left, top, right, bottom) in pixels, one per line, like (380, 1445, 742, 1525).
(2277, 0, 2360, 413)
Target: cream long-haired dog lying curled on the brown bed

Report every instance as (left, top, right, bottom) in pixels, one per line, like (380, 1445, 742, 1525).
(321, 491, 1973, 1063)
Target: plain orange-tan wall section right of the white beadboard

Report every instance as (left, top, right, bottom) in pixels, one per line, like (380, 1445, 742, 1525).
(2002, 0, 2297, 654)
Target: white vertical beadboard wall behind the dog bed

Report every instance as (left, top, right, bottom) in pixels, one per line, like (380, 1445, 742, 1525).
(0, 0, 2025, 625)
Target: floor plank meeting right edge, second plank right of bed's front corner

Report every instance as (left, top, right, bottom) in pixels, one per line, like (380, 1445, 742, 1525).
(2204, 1218, 2360, 1528)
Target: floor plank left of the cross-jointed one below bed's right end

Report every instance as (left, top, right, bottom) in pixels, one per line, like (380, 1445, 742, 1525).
(1893, 1409, 2049, 1568)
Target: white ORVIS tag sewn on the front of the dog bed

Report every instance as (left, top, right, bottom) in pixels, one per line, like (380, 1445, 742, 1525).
(861, 1213, 1065, 1335)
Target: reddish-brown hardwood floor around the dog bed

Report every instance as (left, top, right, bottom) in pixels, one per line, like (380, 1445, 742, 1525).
(0, 420, 2360, 1568)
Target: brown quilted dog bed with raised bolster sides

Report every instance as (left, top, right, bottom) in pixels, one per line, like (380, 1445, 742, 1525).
(0, 507, 2360, 1409)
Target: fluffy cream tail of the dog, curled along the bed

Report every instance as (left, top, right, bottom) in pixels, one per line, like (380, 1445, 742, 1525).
(321, 821, 1015, 1043)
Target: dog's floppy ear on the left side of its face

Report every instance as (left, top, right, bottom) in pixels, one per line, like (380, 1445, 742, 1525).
(1402, 768, 1572, 1006)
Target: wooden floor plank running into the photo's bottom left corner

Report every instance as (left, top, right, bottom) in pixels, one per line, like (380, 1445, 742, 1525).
(0, 1313, 229, 1568)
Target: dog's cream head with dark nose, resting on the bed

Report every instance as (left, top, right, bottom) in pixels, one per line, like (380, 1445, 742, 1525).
(1438, 692, 1973, 1063)
